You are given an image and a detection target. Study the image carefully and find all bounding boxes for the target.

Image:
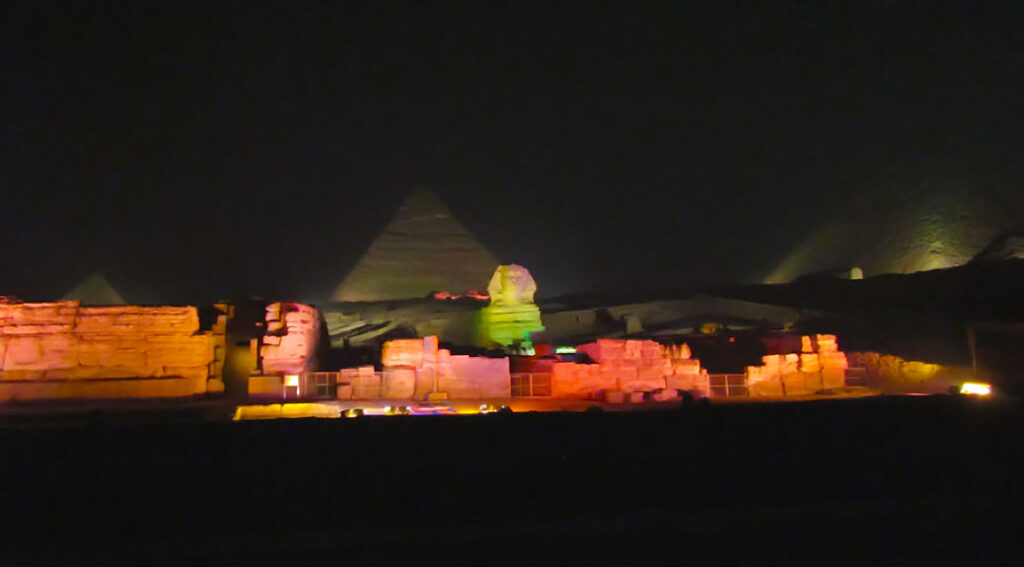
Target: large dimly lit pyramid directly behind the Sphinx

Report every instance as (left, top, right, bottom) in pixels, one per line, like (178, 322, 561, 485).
(332, 189, 501, 301)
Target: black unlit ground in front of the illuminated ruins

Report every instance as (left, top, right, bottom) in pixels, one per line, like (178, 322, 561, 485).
(0, 396, 1024, 565)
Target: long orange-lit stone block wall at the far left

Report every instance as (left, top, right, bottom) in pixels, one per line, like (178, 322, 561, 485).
(0, 301, 227, 400)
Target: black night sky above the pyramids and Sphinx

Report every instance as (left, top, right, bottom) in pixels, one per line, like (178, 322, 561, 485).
(0, 1, 1024, 302)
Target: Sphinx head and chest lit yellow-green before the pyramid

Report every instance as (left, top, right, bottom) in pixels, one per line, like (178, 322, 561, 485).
(478, 264, 544, 347)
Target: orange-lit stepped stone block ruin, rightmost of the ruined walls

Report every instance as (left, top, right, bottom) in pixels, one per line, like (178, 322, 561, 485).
(746, 335, 849, 397)
